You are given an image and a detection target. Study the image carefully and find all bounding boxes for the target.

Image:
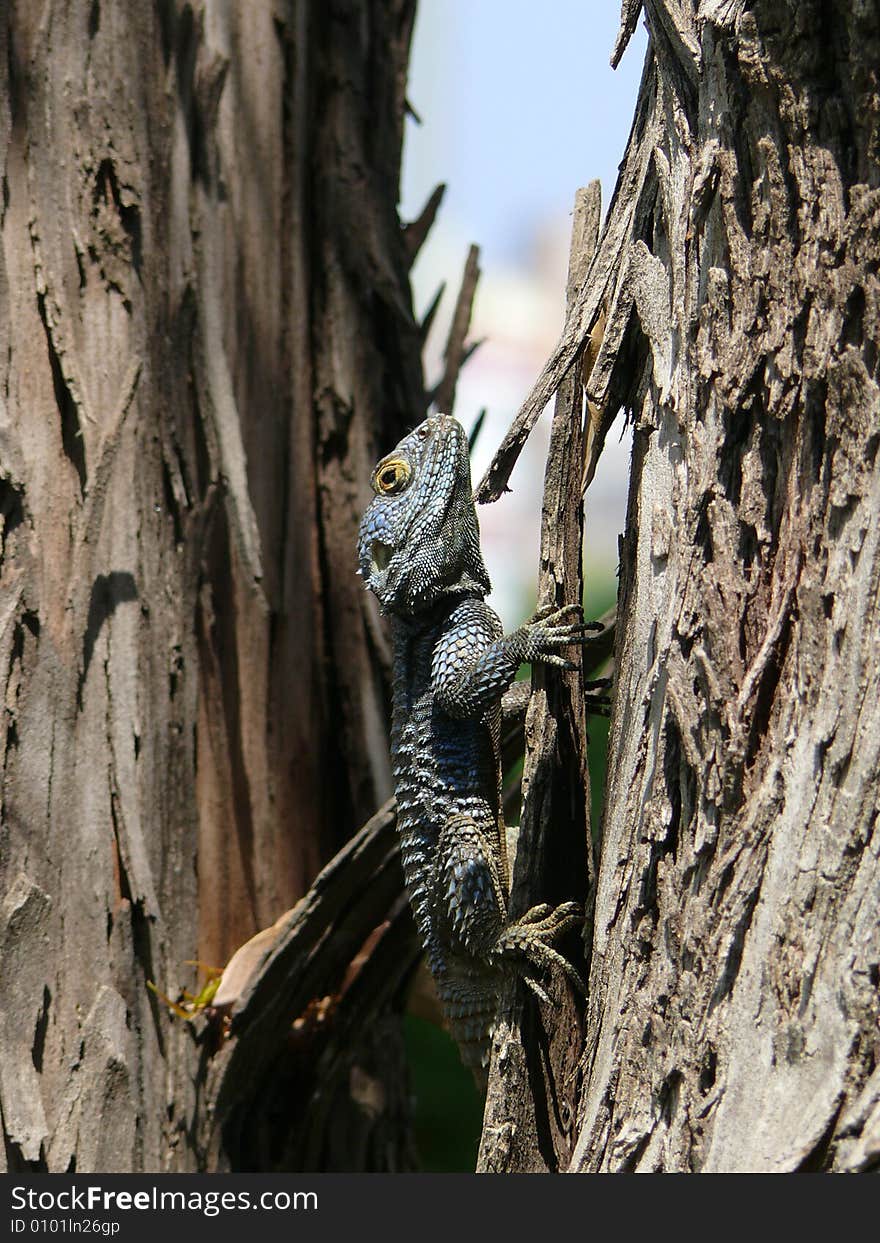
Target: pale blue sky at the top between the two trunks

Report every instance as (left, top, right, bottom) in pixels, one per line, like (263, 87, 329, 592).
(403, 0, 645, 264)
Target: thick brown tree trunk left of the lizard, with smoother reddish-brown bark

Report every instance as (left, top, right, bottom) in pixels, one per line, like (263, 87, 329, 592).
(0, 0, 424, 1171)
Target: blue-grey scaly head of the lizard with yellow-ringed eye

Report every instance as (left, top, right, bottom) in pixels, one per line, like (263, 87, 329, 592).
(358, 414, 490, 617)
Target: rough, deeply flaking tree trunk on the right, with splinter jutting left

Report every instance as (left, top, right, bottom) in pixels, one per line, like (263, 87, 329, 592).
(564, 0, 880, 1171)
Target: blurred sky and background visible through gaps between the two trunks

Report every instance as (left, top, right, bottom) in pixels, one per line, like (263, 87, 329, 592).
(400, 0, 646, 1170)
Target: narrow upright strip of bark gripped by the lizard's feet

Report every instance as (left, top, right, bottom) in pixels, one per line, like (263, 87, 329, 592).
(477, 181, 600, 1171)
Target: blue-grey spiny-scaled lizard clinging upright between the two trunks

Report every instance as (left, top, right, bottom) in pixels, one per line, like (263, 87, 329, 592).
(358, 414, 600, 1085)
